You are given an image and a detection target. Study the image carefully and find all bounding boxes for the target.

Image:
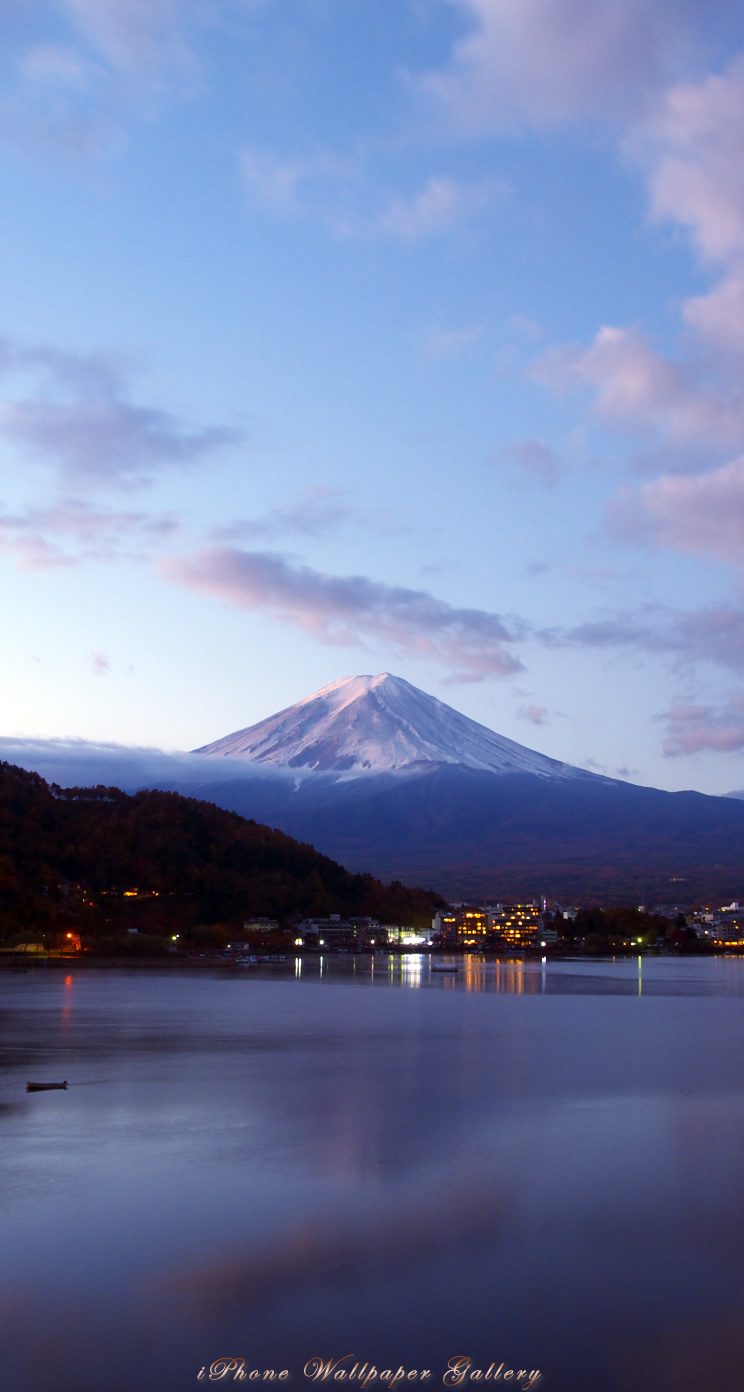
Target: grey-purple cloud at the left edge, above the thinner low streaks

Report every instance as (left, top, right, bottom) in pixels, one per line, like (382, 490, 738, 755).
(0, 340, 241, 487)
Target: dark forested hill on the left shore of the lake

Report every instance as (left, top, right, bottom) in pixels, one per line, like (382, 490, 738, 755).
(0, 763, 442, 937)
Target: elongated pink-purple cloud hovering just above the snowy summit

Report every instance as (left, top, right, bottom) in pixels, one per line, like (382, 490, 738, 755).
(162, 547, 522, 682)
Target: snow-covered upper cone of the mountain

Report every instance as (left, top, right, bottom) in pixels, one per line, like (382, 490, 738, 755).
(195, 672, 588, 778)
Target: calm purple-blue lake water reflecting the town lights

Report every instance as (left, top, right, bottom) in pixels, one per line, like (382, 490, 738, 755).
(0, 959, 744, 1392)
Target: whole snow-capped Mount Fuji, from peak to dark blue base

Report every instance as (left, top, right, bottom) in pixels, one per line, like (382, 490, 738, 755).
(188, 672, 744, 905)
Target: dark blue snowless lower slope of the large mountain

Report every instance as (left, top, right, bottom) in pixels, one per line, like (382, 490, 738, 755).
(179, 766, 744, 905)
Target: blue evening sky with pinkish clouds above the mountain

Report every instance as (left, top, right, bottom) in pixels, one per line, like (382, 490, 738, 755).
(0, 0, 744, 793)
